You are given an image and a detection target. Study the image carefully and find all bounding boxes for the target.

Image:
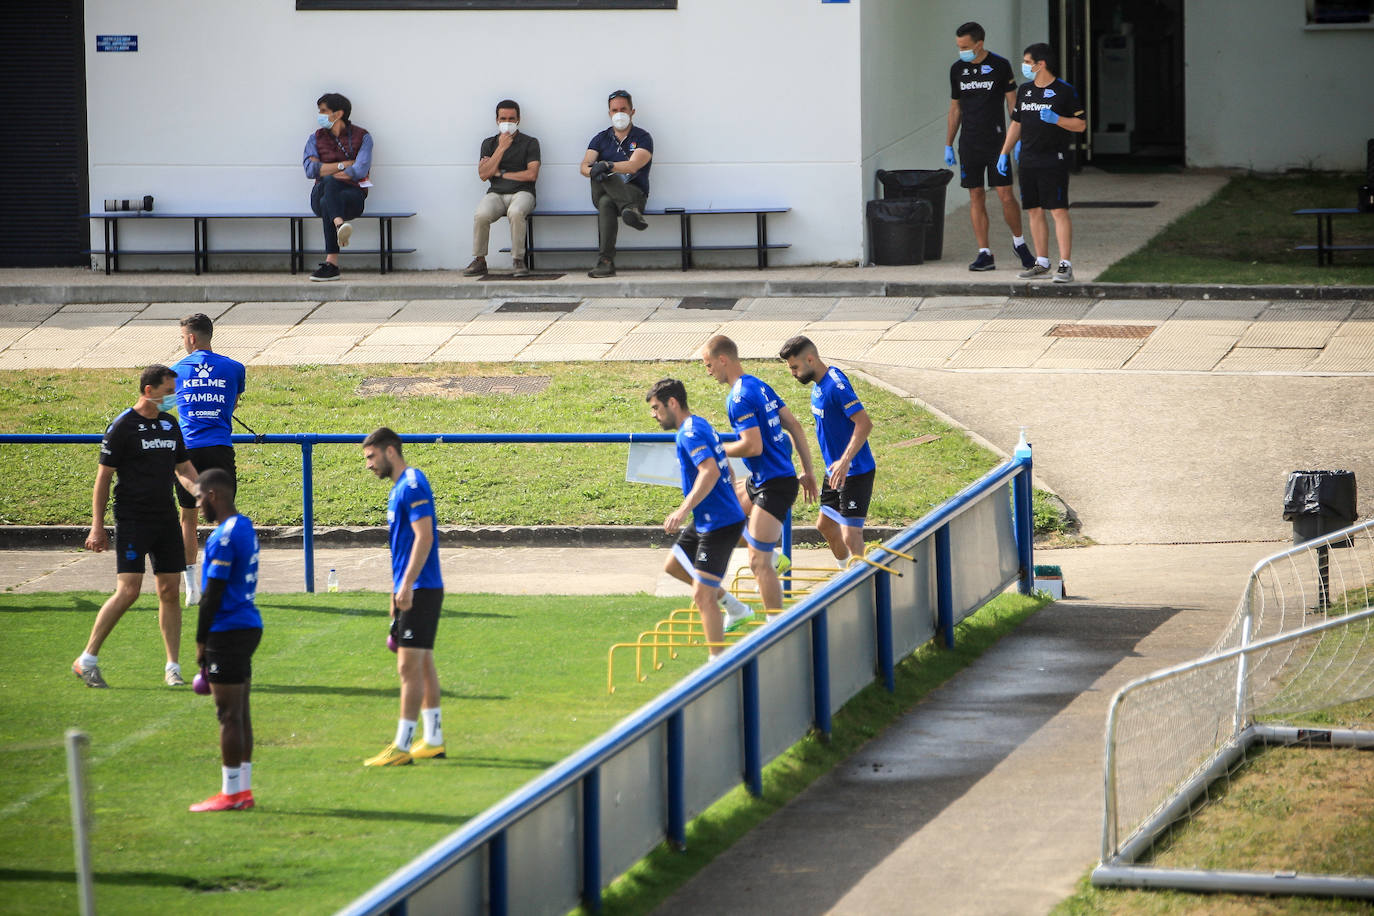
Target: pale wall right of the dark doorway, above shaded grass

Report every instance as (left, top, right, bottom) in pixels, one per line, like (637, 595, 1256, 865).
(1184, 0, 1374, 170)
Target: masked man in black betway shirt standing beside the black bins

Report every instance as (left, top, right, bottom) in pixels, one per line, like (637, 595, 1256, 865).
(945, 22, 1035, 271)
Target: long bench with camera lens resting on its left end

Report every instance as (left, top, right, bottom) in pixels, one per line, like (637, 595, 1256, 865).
(81, 210, 415, 275)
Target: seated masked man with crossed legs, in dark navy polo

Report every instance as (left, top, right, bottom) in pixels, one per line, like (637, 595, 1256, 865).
(581, 89, 654, 277)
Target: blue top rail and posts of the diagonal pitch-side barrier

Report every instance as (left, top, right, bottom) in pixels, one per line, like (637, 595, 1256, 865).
(339, 455, 1033, 916)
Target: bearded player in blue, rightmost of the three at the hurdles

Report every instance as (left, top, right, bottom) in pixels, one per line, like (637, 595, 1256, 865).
(778, 336, 875, 569)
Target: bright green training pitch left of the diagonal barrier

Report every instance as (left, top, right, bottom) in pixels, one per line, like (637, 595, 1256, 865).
(0, 593, 692, 913)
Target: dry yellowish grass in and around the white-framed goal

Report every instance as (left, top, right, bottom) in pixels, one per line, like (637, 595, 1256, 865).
(1052, 700, 1374, 916)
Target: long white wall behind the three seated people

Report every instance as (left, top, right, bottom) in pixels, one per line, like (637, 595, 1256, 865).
(85, 0, 861, 269)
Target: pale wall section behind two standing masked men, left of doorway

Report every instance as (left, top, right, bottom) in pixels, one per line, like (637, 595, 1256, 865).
(860, 0, 1048, 247)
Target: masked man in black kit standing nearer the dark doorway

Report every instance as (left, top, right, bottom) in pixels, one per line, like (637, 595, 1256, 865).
(998, 41, 1088, 283)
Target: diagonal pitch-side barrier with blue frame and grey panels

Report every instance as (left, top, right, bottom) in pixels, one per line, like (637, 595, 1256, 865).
(339, 448, 1033, 916)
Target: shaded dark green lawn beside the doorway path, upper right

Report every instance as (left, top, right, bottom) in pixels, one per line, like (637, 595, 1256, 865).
(1098, 172, 1374, 286)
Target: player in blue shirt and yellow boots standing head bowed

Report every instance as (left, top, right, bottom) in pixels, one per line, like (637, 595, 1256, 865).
(363, 426, 445, 766)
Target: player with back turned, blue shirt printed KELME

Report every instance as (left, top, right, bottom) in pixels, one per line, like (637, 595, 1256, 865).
(164, 312, 246, 606)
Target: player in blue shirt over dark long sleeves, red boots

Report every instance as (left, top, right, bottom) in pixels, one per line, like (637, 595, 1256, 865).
(191, 467, 262, 812)
